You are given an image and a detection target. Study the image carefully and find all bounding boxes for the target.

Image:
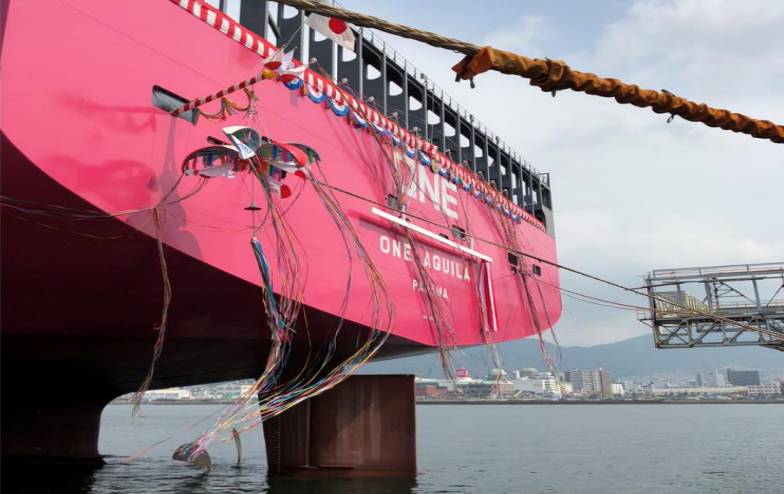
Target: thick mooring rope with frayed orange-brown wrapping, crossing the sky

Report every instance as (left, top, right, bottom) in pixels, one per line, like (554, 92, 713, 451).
(278, 0, 784, 143)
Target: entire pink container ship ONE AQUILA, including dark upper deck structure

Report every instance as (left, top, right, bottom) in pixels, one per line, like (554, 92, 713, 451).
(2, 0, 561, 468)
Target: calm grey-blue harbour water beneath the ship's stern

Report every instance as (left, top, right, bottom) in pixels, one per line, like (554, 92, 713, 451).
(3, 405, 784, 494)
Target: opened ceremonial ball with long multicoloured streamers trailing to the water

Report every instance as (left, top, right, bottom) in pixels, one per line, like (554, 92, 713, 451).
(174, 126, 392, 464)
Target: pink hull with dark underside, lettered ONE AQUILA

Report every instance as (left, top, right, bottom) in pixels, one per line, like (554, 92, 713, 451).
(2, 0, 561, 396)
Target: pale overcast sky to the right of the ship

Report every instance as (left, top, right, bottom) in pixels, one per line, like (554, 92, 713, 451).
(341, 0, 784, 345)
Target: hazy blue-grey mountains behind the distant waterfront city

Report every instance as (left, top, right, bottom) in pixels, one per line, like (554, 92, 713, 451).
(364, 335, 784, 378)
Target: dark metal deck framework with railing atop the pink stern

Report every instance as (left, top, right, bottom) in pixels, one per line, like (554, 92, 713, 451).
(224, 0, 554, 234)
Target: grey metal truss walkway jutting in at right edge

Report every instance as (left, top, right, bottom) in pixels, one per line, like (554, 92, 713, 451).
(639, 262, 784, 351)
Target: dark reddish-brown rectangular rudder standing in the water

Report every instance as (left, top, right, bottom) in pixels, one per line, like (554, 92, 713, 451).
(264, 375, 416, 477)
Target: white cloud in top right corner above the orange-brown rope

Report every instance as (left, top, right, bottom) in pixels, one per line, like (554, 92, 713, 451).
(587, 0, 784, 114)
